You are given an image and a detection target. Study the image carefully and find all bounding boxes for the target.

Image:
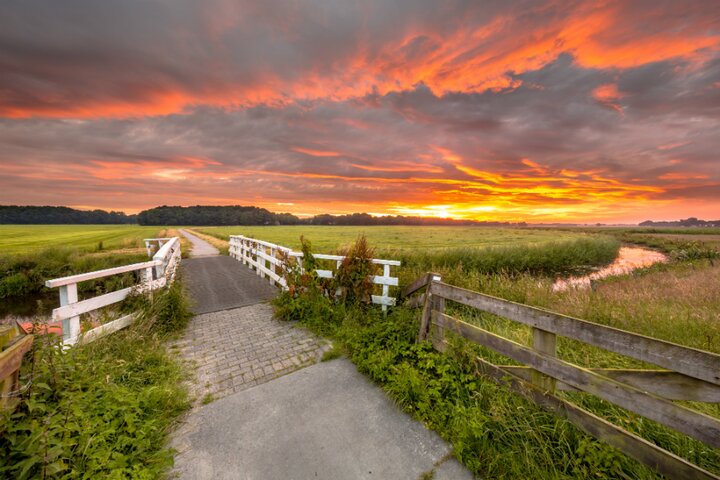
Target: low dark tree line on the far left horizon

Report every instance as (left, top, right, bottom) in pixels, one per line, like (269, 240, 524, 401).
(0, 205, 137, 225)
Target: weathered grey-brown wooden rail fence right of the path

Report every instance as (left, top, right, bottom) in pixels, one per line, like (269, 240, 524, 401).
(403, 273, 720, 480)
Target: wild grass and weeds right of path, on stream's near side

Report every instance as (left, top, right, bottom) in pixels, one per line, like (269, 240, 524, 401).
(276, 232, 720, 479)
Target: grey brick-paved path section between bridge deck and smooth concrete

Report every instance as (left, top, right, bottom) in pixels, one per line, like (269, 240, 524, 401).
(171, 303, 329, 402)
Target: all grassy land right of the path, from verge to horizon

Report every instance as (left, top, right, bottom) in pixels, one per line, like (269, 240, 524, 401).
(260, 227, 720, 478)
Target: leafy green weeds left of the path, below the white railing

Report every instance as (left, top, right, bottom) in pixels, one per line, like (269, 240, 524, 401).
(0, 283, 190, 479)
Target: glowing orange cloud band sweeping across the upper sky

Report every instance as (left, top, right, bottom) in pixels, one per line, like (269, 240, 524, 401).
(0, 1, 720, 118)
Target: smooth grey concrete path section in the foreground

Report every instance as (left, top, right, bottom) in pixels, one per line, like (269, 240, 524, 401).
(173, 359, 472, 480)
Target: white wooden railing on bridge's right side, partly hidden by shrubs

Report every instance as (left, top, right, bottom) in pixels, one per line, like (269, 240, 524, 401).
(229, 235, 400, 310)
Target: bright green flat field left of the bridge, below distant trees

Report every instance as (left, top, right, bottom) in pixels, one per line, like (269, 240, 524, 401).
(0, 225, 160, 255)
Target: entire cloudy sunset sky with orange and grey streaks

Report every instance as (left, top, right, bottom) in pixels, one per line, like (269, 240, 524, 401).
(0, 0, 720, 223)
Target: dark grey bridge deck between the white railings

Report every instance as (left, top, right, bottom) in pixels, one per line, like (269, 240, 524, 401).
(180, 255, 278, 314)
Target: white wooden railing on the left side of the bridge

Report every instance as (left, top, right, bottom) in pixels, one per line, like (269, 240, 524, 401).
(45, 237, 180, 345)
